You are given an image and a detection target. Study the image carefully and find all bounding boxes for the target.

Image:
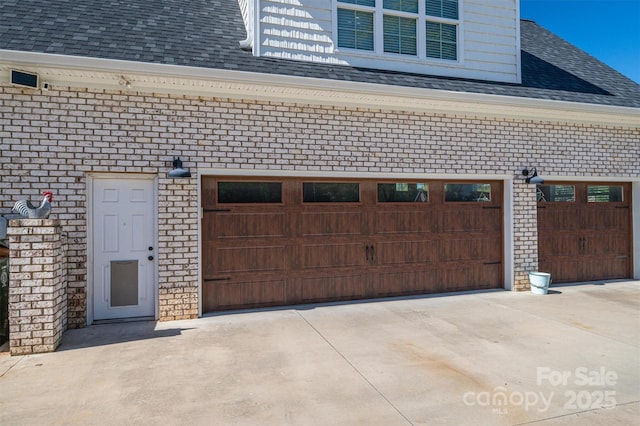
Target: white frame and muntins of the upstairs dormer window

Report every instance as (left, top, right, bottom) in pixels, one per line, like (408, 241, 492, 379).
(332, 0, 464, 66)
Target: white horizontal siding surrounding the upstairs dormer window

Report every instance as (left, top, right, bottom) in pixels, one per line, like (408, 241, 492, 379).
(256, 0, 520, 83)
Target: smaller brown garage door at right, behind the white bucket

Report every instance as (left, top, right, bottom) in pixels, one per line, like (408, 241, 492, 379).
(537, 182, 632, 283)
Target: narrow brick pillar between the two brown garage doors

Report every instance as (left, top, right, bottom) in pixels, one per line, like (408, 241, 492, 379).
(513, 181, 538, 291)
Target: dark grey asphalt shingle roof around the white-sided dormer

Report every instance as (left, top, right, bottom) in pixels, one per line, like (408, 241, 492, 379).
(0, 0, 640, 107)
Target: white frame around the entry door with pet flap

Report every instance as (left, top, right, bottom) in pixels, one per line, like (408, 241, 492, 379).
(86, 173, 159, 325)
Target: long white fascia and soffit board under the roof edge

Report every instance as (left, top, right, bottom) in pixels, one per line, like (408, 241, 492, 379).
(0, 50, 640, 128)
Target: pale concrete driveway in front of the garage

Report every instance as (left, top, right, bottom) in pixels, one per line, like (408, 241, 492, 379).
(0, 281, 640, 426)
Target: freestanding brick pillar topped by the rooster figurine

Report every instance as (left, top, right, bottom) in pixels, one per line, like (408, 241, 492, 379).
(7, 219, 67, 355)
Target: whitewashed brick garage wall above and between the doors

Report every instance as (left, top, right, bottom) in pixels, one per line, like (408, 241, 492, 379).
(0, 86, 640, 327)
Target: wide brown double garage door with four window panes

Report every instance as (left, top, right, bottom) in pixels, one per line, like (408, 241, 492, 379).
(202, 177, 503, 312)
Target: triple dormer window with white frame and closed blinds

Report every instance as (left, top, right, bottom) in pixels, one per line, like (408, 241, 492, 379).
(337, 0, 460, 61)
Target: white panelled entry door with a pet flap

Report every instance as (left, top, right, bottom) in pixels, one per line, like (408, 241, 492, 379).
(91, 178, 156, 320)
